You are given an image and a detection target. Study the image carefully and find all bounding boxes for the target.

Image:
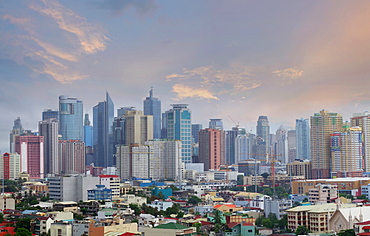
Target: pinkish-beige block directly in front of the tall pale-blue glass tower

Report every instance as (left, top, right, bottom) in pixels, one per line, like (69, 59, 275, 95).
(58, 140, 85, 174)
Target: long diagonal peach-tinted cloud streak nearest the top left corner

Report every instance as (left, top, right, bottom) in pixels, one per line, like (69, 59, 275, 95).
(29, 0, 109, 54)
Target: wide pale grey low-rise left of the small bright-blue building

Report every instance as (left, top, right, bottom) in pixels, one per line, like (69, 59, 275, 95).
(49, 175, 99, 202)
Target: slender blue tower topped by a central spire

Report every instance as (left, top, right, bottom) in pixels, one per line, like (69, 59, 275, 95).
(144, 87, 162, 139)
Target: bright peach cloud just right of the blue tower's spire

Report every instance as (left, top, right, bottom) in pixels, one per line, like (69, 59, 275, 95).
(172, 84, 220, 100)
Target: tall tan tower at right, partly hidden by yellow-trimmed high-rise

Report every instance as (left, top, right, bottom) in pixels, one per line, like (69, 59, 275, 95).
(310, 110, 343, 179)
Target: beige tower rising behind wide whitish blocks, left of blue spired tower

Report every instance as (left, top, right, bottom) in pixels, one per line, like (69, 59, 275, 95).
(125, 111, 153, 145)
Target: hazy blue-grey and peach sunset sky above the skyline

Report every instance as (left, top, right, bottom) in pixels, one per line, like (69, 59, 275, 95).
(0, 0, 370, 152)
